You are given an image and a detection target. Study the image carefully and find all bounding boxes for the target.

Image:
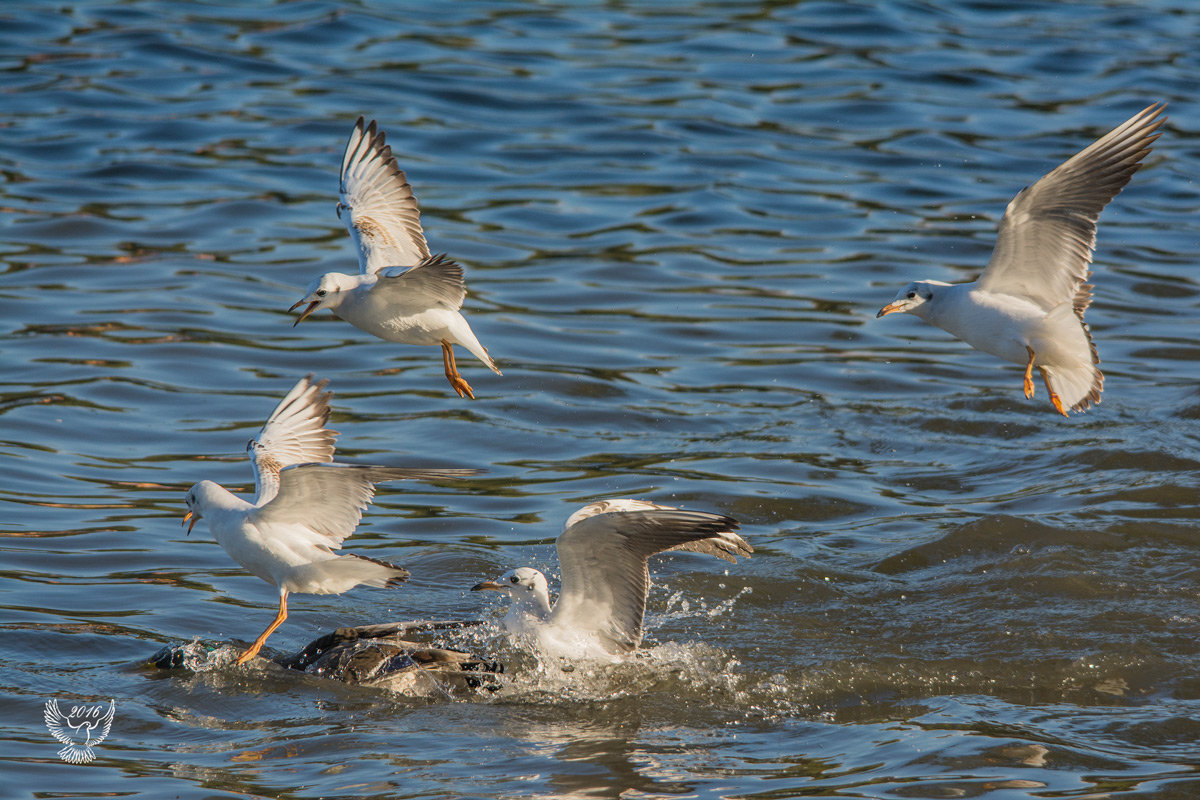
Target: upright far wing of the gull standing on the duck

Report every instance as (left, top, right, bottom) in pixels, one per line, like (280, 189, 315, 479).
(246, 374, 337, 505)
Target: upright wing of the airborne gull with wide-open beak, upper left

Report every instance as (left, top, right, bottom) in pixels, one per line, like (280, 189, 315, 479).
(337, 116, 430, 275)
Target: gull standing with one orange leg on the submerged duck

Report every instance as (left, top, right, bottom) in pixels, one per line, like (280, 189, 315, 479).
(184, 375, 479, 664)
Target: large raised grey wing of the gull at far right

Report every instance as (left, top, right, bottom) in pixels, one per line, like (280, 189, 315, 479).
(979, 104, 1166, 314)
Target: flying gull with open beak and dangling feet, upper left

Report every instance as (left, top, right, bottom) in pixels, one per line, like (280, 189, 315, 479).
(288, 116, 503, 399)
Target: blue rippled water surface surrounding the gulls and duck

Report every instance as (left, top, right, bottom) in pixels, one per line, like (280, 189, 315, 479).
(0, 0, 1200, 799)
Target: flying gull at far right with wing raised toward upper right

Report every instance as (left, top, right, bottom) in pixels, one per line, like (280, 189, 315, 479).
(876, 103, 1166, 416)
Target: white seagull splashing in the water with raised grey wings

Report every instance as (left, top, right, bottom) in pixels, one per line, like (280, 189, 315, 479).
(472, 500, 754, 658)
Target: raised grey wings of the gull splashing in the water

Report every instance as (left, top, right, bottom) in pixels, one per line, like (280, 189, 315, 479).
(550, 500, 754, 652)
